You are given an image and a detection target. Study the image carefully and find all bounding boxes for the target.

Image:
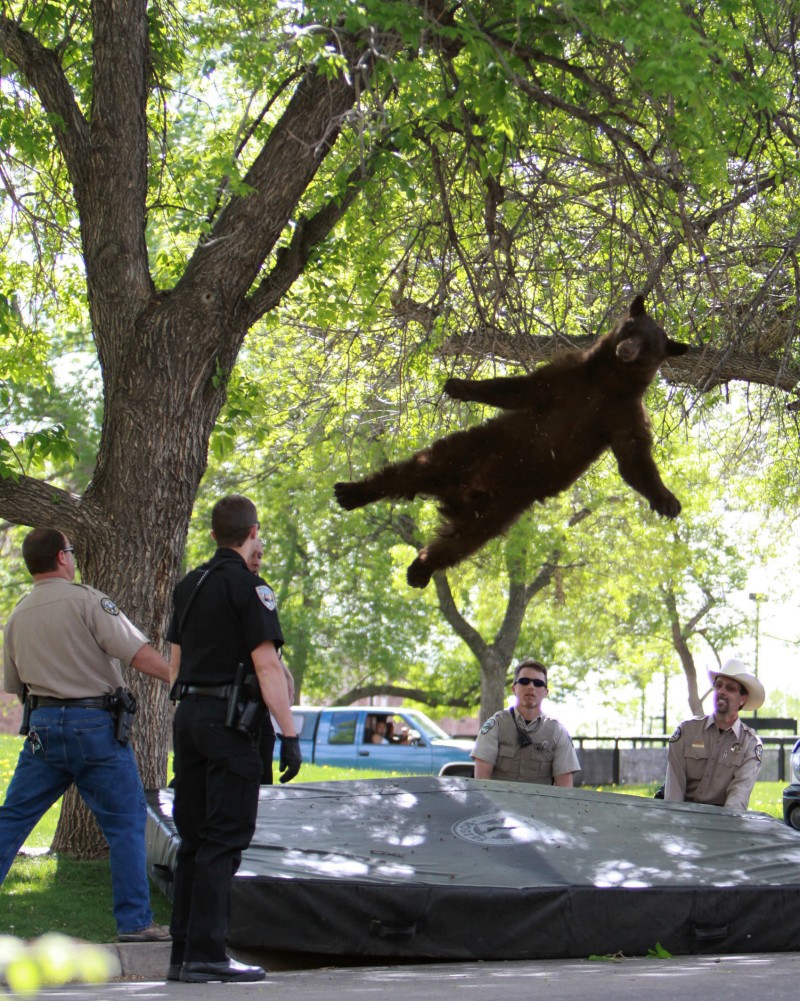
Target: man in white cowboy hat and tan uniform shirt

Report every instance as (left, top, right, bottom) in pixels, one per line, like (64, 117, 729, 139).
(664, 661, 765, 810)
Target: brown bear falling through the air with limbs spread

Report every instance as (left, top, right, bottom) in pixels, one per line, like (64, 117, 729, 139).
(334, 295, 688, 588)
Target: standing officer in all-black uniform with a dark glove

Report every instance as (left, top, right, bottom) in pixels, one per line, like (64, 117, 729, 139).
(167, 494, 301, 983)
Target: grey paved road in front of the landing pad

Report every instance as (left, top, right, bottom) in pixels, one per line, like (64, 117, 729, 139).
(28, 953, 800, 1001)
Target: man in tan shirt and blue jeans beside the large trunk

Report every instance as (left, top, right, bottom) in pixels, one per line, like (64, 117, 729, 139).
(0, 529, 169, 942)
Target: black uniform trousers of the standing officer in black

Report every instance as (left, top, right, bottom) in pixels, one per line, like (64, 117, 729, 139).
(170, 695, 261, 964)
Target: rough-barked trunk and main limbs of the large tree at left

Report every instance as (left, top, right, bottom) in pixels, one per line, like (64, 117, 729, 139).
(0, 0, 384, 857)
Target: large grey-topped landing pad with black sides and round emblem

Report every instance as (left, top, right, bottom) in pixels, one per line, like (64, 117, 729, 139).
(147, 777, 800, 960)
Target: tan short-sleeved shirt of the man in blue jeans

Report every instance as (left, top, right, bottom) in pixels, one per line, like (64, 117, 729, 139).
(3, 578, 147, 699)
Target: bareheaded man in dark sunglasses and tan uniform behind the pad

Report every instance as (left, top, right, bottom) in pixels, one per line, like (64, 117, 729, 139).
(472, 660, 581, 788)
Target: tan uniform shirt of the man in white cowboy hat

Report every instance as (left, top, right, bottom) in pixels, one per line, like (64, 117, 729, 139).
(664, 716, 762, 810)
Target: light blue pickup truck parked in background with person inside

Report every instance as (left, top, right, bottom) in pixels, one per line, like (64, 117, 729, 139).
(275, 706, 474, 775)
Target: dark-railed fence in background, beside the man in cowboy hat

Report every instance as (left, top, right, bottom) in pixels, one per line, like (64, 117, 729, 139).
(573, 734, 798, 786)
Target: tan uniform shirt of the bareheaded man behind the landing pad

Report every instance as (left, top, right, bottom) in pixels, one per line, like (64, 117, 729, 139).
(471, 709, 581, 786)
